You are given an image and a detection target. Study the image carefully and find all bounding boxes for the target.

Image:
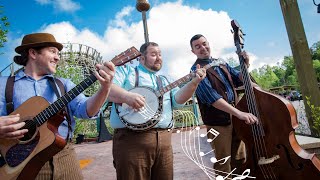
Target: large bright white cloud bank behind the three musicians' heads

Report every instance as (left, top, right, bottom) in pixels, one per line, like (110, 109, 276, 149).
(10, 0, 276, 79)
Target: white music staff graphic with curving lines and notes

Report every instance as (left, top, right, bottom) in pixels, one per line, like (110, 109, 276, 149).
(174, 110, 255, 180)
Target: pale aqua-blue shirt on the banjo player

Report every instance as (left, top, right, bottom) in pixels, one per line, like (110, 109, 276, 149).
(110, 64, 184, 128)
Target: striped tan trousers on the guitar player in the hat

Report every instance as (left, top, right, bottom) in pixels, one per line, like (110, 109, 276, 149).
(36, 143, 83, 180)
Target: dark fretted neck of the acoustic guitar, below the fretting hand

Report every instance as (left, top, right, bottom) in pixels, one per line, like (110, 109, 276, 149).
(35, 74, 97, 126)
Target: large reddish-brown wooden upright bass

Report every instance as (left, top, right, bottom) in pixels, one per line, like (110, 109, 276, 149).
(231, 20, 320, 180)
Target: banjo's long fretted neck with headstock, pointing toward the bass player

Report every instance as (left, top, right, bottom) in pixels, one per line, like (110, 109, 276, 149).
(155, 59, 225, 97)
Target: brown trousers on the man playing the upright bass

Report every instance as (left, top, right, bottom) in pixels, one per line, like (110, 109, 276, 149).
(207, 124, 246, 176)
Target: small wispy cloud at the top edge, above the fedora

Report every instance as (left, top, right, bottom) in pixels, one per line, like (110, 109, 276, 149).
(35, 0, 81, 12)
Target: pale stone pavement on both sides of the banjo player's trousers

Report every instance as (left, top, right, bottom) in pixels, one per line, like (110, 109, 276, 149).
(74, 129, 213, 180)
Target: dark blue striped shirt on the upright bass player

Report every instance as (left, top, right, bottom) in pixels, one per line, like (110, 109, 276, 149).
(191, 59, 242, 105)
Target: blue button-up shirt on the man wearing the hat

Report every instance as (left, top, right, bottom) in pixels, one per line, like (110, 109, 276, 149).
(0, 70, 95, 138)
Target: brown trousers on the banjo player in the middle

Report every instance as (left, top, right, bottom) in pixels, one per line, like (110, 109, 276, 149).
(112, 129, 173, 180)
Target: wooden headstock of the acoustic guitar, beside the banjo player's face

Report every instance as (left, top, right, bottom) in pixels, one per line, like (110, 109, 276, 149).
(111, 46, 141, 66)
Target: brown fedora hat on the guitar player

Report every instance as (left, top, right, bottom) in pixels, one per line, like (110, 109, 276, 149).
(15, 33, 63, 54)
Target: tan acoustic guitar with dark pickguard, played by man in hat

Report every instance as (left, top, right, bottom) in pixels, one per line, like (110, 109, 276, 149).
(0, 47, 141, 180)
